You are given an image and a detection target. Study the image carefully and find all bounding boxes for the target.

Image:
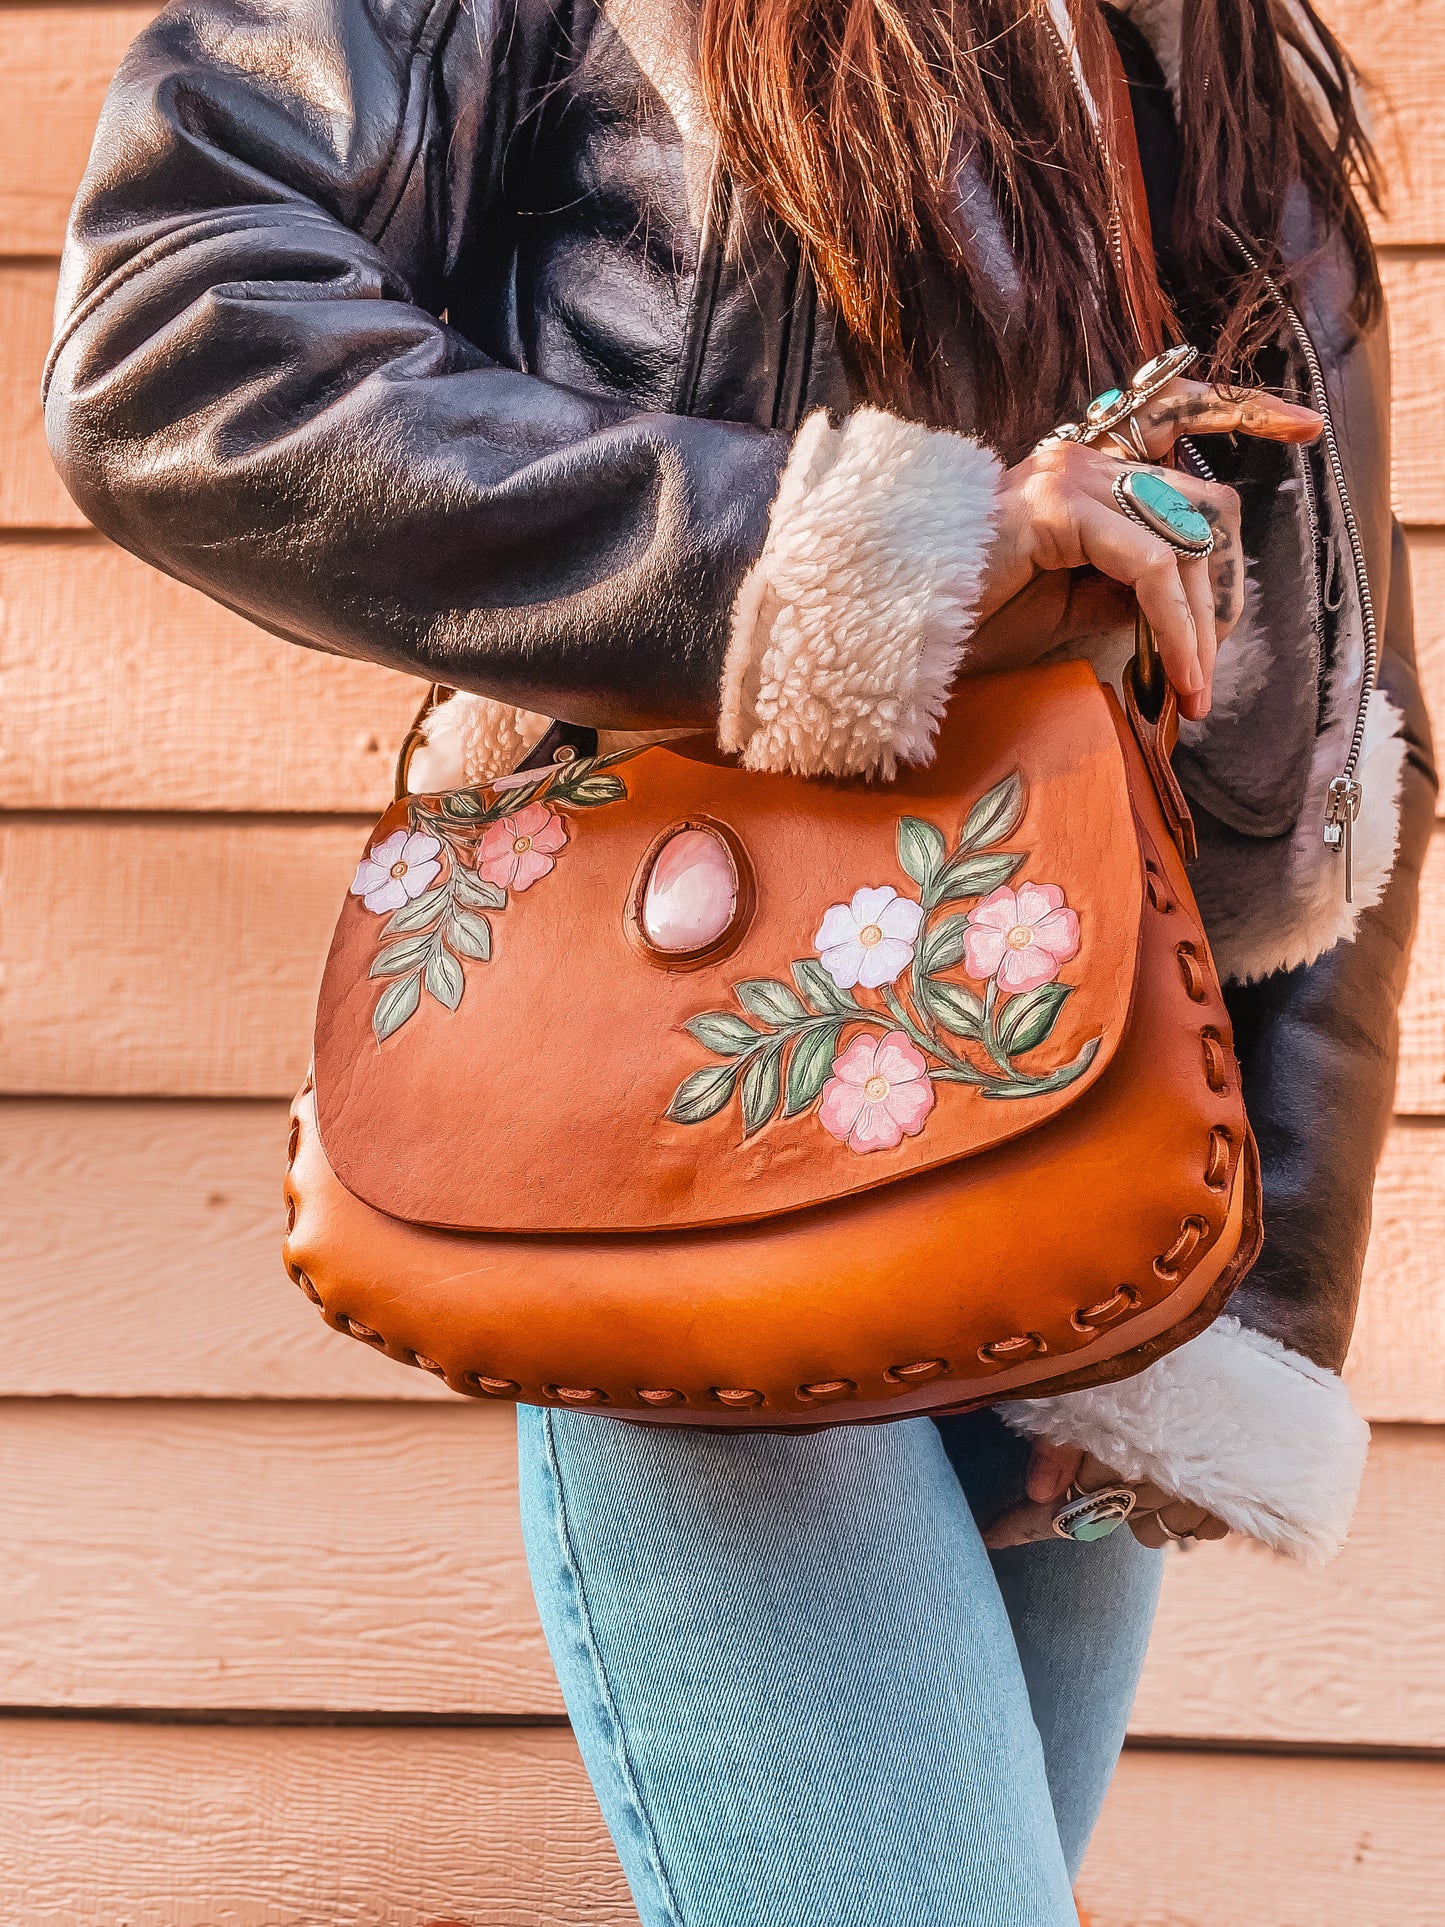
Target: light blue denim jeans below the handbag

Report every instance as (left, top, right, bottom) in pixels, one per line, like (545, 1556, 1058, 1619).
(520, 1409, 1162, 1927)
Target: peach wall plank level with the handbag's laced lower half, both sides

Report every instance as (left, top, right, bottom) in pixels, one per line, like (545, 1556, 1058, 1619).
(0, 1098, 1445, 1424)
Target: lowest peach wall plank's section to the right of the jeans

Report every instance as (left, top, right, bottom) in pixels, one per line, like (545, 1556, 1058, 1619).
(1079, 1752, 1445, 1927)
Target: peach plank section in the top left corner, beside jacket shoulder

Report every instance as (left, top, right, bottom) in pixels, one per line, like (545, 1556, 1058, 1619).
(0, 0, 158, 254)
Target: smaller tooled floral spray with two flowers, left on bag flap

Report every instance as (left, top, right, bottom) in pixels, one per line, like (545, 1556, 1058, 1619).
(360, 750, 636, 1043)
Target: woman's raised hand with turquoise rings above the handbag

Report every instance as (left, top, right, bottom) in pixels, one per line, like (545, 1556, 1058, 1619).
(973, 380, 1324, 719)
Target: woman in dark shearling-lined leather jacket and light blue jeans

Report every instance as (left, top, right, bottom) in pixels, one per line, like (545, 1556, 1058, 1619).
(46, 0, 1430, 1927)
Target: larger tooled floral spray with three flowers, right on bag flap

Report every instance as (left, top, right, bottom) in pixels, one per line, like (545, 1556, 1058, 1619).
(667, 771, 1102, 1154)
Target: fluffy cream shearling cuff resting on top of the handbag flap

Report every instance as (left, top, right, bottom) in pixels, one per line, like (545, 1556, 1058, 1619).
(719, 409, 1002, 779)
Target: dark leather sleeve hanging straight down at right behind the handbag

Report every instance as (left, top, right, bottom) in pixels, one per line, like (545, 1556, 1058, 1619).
(1227, 526, 1435, 1372)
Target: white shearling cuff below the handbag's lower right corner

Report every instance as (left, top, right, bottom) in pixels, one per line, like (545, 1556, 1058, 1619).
(998, 1314, 1370, 1565)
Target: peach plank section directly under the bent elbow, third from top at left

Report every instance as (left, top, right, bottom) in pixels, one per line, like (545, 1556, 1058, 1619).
(0, 538, 426, 815)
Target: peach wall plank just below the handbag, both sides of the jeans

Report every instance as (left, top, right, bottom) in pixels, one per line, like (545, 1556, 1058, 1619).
(0, 1399, 1445, 1748)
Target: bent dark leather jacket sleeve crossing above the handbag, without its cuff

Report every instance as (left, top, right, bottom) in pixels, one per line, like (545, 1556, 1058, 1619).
(46, 0, 790, 726)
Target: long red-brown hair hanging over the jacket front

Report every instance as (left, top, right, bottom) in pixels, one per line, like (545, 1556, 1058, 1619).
(699, 0, 1379, 447)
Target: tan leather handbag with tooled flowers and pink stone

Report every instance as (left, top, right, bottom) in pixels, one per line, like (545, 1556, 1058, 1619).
(285, 628, 1260, 1428)
